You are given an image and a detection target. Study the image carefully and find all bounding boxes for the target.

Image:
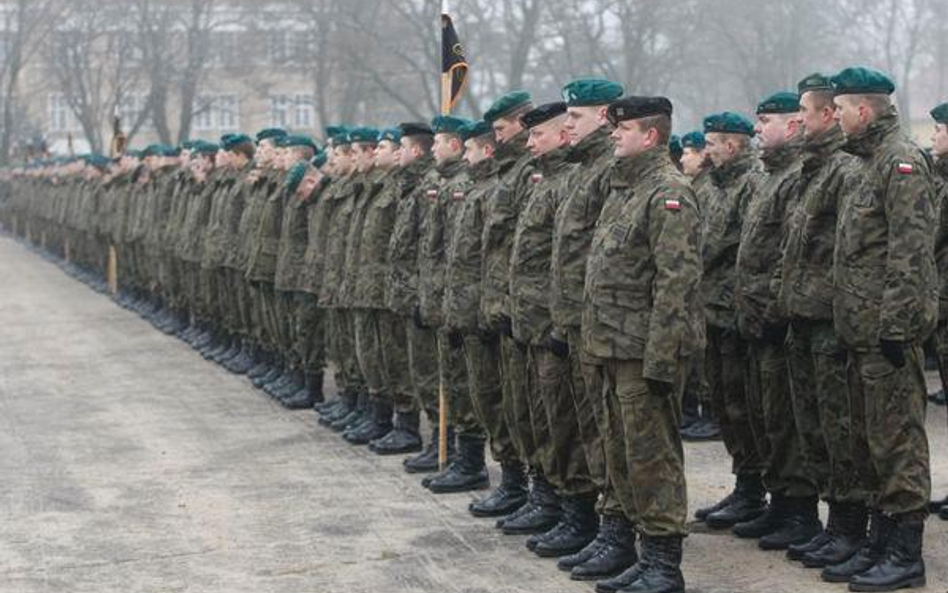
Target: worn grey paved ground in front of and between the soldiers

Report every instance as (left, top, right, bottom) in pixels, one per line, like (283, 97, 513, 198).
(0, 232, 948, 593)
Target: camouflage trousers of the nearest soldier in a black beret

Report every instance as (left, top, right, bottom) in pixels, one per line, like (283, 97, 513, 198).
(597, 360, 688, 537)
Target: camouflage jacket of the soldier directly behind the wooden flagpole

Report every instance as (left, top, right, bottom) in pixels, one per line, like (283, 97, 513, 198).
(418, 158, 471, 327)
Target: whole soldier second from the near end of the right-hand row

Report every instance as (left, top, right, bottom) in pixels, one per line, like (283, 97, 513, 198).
(780, 74, 867, 568)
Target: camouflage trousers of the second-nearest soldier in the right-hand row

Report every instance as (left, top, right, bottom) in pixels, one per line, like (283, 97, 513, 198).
(787, 319, 866, 503)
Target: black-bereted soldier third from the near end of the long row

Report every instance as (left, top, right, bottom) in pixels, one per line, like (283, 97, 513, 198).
(508, 102, 599, 557)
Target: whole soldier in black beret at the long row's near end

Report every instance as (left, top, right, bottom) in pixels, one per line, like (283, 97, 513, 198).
(582, 97, 704, 593)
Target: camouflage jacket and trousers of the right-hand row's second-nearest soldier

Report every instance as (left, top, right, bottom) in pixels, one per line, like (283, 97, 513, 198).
(780, 127, 865, 503)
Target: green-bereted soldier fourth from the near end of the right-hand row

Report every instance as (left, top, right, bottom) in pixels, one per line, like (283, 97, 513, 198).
(695, 112, 766, 529)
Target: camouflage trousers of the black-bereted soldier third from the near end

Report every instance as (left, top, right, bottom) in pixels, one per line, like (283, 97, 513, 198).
(527, 345, 599, 497)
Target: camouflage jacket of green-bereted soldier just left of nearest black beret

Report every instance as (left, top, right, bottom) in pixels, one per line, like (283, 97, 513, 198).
(550, 128, 613, 332)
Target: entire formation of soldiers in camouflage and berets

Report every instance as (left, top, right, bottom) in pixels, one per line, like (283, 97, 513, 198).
(2, 68, 948, 593)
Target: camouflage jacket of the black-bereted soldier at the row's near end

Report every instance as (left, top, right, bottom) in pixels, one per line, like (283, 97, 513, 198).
(582, 147, 704, 383)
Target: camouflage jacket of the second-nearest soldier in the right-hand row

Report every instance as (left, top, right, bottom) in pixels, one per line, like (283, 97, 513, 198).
(780, 127, 856, 321)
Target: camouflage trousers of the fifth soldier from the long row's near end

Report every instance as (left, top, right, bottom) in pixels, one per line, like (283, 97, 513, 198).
(464, 334, 519, 463)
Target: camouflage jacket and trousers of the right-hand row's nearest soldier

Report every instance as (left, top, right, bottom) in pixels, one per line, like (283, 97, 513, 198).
(833, 108, 938, 516)
